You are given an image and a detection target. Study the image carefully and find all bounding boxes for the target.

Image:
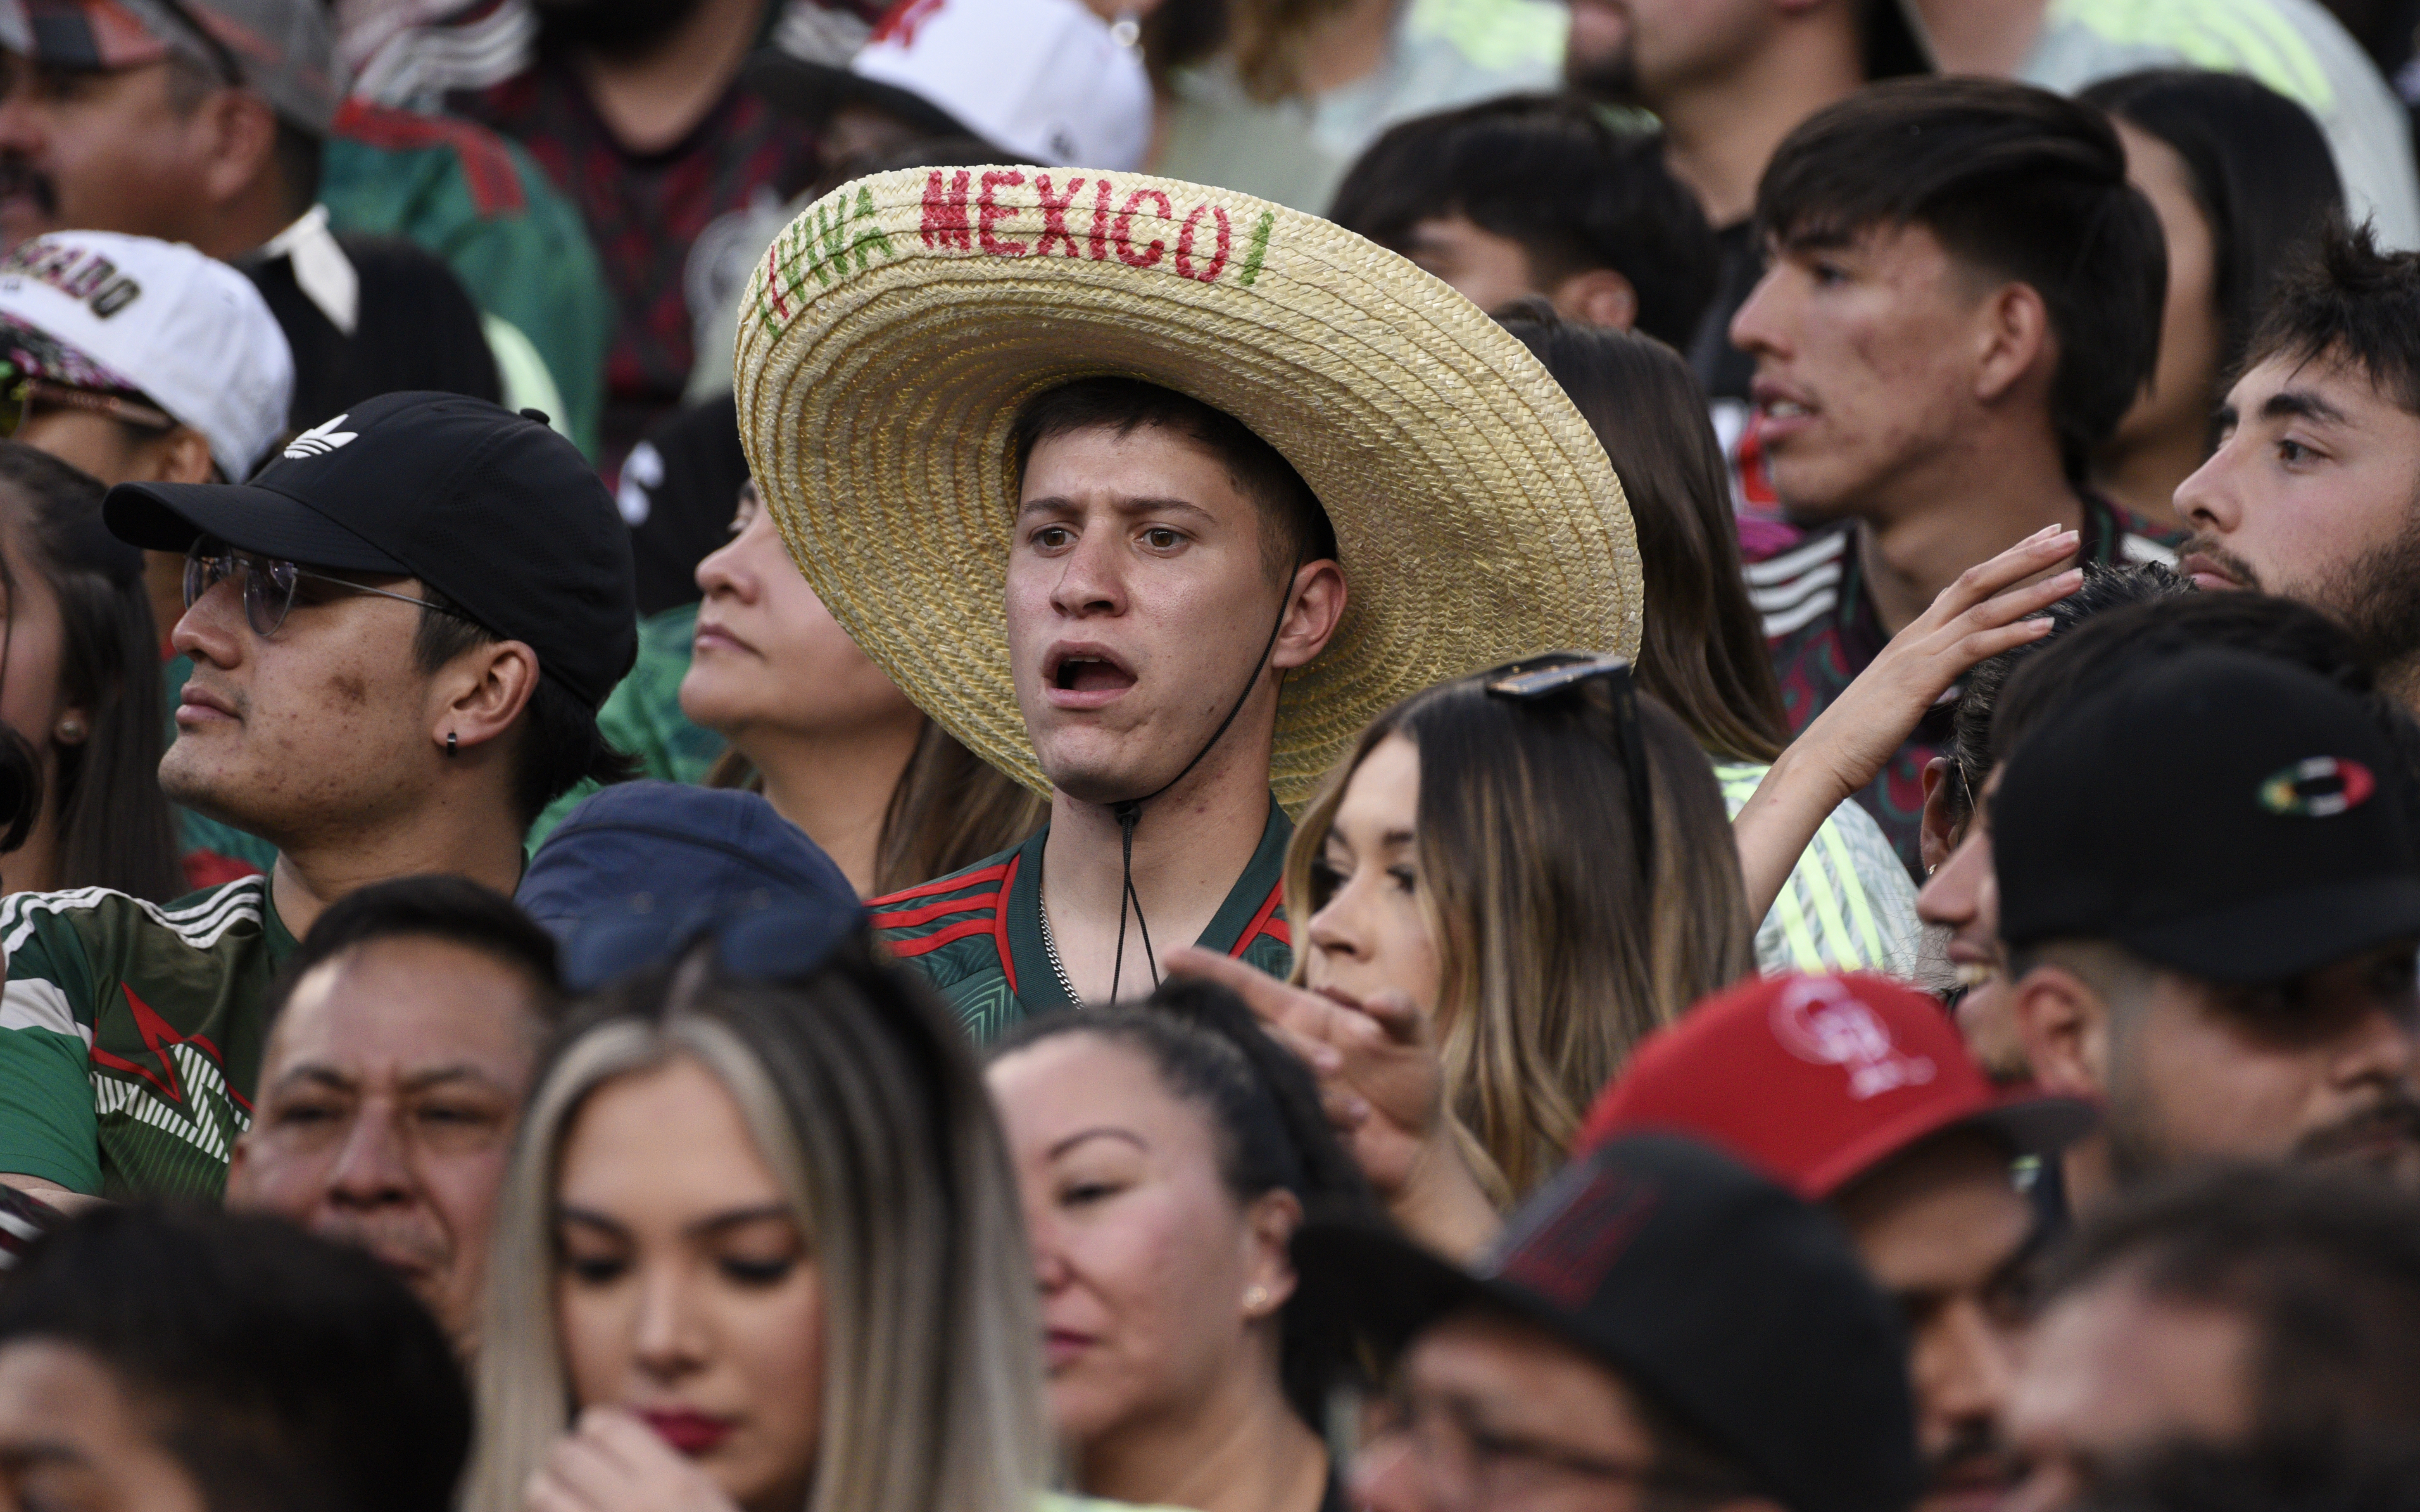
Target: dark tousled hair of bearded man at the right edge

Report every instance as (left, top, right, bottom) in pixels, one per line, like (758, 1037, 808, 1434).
(2243, 223, 2420, 414)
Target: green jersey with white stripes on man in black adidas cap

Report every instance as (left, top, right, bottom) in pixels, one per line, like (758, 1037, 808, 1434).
(0, 876, 295, 1200)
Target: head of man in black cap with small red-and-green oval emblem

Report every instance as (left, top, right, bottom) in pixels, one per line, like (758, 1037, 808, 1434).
(1989, 651, 2420, 1212)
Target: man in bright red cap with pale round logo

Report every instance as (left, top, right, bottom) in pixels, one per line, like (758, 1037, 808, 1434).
(1578, 977, 2093, 1512)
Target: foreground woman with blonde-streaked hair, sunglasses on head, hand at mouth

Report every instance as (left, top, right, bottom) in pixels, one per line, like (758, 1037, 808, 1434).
(467, 910, 1050, 1512)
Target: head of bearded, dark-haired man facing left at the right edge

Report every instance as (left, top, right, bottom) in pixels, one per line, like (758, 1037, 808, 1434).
(2175, 230, 2420, 711)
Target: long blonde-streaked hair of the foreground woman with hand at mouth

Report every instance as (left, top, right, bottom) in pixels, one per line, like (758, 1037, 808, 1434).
(465, 941, 1050, 1512)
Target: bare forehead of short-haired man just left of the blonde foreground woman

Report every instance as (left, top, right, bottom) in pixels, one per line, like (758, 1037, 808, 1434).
(261, 939, 537, 1084)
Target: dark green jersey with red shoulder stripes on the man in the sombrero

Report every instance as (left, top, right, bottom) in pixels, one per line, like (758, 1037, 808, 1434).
(866, 803, 1295, 1045)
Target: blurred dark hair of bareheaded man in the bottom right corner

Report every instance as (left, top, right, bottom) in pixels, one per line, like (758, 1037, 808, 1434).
(2042, 1166, 2420, 1459)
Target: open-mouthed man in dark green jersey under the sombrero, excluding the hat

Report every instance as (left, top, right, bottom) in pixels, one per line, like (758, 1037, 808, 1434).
(874, 378, 1346, 1030)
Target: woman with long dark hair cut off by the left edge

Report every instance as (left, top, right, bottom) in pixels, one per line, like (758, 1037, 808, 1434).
(0, 443, 189, 902)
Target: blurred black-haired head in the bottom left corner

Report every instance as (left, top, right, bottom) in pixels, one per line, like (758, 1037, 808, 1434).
(0, 1207, 472, 1512)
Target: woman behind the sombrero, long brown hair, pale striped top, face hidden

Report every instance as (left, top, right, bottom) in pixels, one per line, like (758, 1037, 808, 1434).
(1498, 300, 1919, 975)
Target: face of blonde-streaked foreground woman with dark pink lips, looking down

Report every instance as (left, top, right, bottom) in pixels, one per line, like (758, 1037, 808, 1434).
(554, 1057, 823, 1512)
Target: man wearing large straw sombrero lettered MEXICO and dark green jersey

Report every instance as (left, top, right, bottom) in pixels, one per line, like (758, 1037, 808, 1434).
(736, 167, 1641, 1038)
